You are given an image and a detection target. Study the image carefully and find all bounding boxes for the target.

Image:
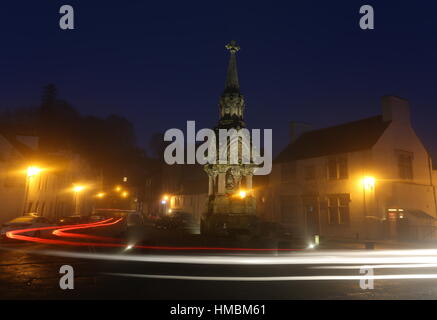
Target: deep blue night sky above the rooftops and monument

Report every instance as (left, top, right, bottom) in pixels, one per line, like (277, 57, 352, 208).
(0, 0, 437, 161)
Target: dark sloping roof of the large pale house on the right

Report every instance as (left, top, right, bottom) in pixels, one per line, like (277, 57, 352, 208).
(275, 115, 390, 163)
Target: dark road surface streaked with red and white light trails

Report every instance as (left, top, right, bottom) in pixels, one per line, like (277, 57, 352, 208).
(0, 219, 437, 300)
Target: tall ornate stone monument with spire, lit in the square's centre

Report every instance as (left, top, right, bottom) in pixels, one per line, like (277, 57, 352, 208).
(203, 41, 256, 235)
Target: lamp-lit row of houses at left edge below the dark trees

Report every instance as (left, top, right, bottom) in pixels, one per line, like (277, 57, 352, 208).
(0, 134, 91, 223)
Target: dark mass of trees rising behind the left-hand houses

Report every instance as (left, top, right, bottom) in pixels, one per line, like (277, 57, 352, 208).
(0, 85, 149, 185)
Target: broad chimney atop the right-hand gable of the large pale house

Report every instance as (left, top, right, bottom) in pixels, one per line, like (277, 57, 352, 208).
(381, 96, 410, 125)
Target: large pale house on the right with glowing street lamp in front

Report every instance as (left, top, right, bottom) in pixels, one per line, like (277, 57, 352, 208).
(266, 96, 437, 240)
